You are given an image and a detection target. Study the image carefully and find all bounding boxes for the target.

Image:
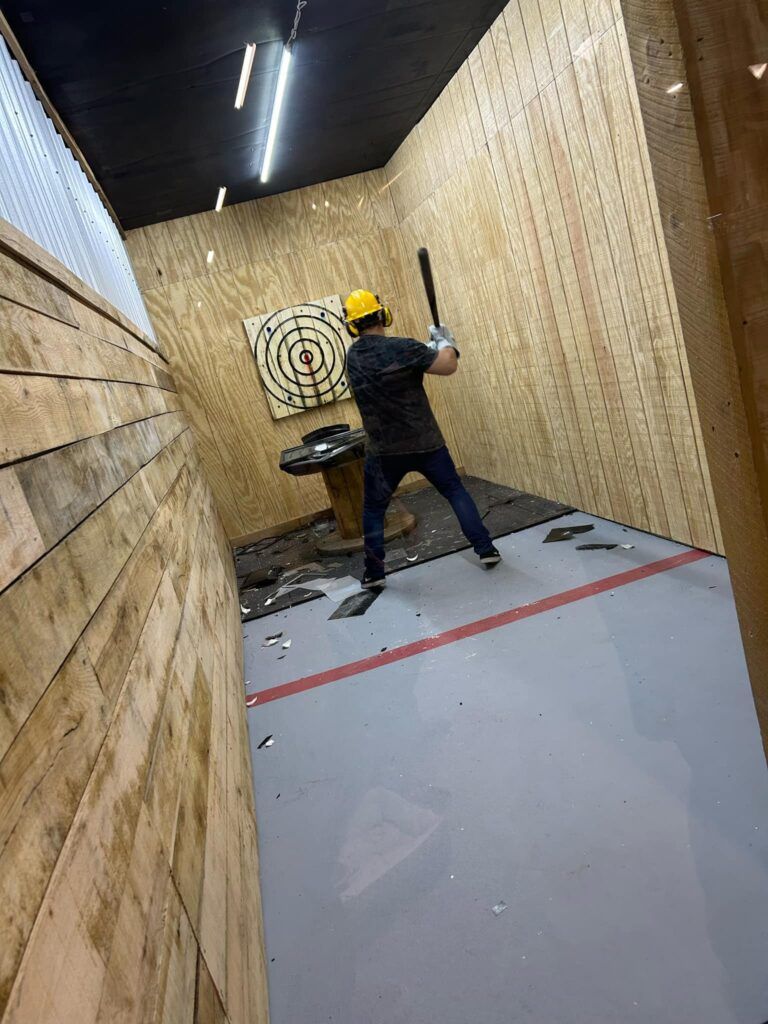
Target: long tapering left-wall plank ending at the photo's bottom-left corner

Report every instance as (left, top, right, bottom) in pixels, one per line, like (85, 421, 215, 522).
(6, 582, 185, 1022)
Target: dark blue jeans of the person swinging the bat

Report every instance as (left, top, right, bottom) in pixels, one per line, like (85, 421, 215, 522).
(362, 445, 494, 575)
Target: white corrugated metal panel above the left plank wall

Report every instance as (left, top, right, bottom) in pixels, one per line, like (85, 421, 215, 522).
(0, 39, 155, 338)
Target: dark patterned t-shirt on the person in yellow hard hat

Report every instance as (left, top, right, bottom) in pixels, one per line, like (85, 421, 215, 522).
(347, 334, 445, 455)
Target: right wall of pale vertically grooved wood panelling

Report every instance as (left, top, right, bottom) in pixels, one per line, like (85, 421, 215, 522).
(386, 0, 722, 551)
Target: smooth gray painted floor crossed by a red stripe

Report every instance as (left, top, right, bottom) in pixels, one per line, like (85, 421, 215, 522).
(244, 515, 768, 1024)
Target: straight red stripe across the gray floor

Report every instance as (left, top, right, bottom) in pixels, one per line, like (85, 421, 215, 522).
(246, 550, 709, 708)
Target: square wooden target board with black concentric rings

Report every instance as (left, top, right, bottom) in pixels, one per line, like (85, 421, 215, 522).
(243, 295, 351, 420)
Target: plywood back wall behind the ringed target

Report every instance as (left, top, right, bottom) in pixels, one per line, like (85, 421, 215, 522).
(127, 171, 450, 539)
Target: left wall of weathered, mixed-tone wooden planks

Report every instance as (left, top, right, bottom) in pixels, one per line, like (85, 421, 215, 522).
(0, 222, 267, 1024)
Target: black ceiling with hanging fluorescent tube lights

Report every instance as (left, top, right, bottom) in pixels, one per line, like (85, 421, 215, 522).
(2, 0, 514, 228)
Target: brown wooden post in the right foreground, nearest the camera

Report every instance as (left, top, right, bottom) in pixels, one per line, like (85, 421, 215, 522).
(623, 0, 768, 751)
